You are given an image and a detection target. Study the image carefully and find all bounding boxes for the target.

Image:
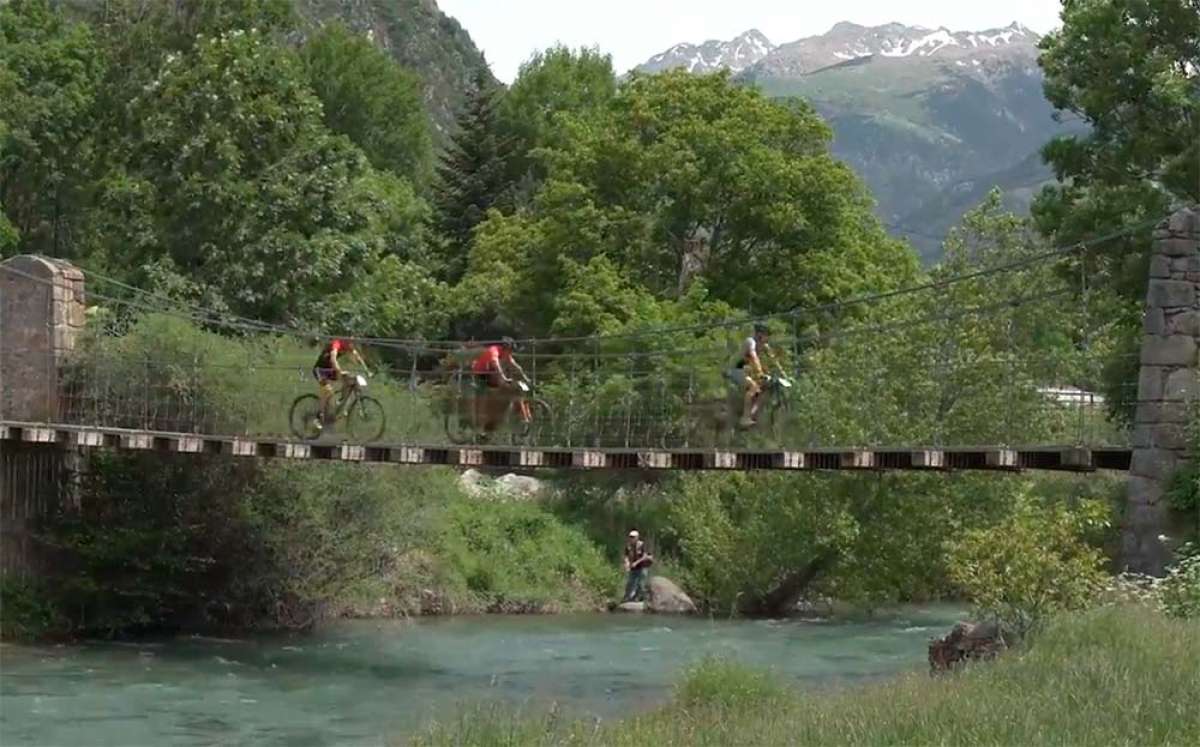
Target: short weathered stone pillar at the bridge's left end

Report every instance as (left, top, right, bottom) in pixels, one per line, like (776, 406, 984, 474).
(0, 255, 85, 423)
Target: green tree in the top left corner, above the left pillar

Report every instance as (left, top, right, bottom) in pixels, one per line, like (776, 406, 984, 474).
(0, 0, 104, 256)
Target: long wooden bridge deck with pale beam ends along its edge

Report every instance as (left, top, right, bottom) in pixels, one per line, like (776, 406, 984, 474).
(0, 422, 1132, 472)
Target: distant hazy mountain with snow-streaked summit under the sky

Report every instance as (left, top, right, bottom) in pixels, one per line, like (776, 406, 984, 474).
(640, 23, 1064, 257)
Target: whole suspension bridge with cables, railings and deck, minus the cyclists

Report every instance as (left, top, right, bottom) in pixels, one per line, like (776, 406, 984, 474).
(0, 213, 1195, 471)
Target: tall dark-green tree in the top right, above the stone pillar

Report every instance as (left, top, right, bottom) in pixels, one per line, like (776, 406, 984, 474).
(1034, 0, 1200, 304)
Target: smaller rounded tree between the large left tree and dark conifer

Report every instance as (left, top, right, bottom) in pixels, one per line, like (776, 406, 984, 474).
(300, 23, 432, 185)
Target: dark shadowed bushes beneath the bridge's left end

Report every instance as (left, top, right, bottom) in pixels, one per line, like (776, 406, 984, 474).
(44, 455, 262, 635)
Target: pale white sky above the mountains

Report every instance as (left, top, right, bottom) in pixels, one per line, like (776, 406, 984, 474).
(438, 0, 1061, 83)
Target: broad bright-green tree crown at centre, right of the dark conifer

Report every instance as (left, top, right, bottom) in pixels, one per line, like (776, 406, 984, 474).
(464, 68, 916, 334)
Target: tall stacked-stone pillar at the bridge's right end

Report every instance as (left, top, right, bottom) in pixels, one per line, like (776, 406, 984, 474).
(1121, 210, 1200, 575)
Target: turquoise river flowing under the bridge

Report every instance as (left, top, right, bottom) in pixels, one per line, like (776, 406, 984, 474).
(0, 605, 961, 747)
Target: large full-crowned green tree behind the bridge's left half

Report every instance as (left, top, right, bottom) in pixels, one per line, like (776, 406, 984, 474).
(88, 30, 415, 319)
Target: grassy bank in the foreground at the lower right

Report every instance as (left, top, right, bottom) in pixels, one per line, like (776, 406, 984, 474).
(415, 606, 1200, 747)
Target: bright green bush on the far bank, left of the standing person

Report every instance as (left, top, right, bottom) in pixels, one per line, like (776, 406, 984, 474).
(437, 498, 618, 612)
